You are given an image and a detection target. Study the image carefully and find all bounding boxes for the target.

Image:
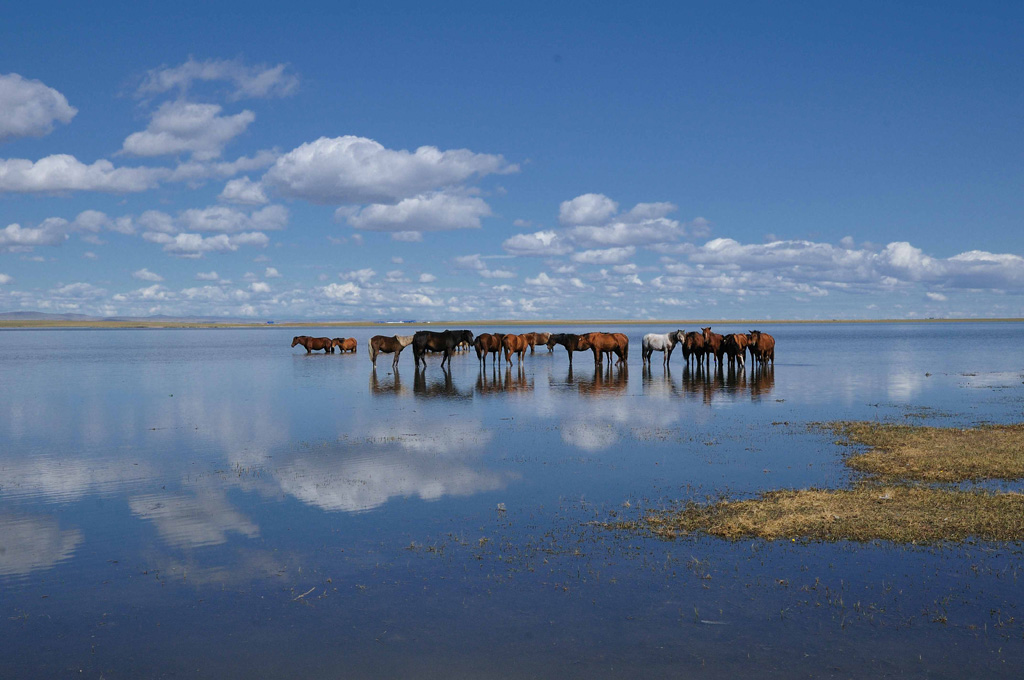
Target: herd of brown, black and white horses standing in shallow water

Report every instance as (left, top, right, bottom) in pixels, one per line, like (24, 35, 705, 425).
(292, 327, 775, 370)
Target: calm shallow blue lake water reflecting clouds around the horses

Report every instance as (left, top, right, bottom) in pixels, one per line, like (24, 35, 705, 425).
(0, 324, 1024, 678)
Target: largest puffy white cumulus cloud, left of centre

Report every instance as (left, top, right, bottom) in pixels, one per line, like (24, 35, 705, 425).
(263, 135, 517, 204)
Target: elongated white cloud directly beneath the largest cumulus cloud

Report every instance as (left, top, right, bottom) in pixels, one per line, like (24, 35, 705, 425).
(347, 192, 492, 231)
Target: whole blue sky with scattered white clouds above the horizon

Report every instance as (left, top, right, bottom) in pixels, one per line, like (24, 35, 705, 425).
(0, 2, 1024, 320)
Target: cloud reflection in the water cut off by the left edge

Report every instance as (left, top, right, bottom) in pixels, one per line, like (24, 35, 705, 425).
(0, 514, 82, 576)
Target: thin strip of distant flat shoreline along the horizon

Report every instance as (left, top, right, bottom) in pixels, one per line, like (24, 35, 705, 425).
(0, 317, 1024, 330)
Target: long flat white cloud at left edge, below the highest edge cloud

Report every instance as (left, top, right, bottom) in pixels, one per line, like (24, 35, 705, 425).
(0, 154, 169, 194)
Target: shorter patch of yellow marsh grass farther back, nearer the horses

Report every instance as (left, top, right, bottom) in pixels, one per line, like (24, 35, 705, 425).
(824, 422, 1024, 482)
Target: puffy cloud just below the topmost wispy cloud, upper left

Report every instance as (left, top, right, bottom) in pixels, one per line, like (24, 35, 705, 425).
(122, 100, 256, 161)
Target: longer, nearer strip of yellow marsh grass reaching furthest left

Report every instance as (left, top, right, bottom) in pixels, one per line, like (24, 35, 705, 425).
(638, 485, 1024, 543)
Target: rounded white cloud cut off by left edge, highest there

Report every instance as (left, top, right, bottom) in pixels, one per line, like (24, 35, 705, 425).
(0, 73, 78, 141)
